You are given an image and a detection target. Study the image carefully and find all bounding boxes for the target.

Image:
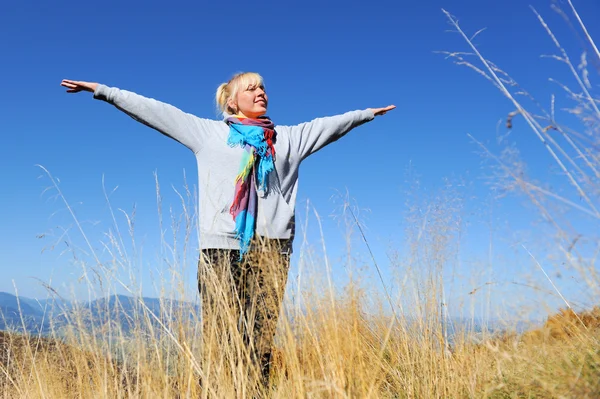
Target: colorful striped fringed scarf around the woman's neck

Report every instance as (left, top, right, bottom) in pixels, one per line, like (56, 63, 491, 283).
(225, 116, 276, 257)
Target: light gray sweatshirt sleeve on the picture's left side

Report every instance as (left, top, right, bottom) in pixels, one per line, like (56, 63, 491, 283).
(94, 84, 213, 153)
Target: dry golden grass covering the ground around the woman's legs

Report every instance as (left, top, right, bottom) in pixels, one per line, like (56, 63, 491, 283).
(0, 291, 600, 398)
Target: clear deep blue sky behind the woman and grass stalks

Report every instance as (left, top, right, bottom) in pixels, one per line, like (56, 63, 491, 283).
(0, 0, 600, 318)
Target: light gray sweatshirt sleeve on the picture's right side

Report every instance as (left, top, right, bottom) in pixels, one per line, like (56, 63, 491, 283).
(290, 109, 375, 160)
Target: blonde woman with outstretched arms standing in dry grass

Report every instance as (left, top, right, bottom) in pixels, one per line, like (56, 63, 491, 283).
(61, 73, 395, 390)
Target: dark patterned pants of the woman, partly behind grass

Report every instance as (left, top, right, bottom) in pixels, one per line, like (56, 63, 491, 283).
(198, 242, 290, 386)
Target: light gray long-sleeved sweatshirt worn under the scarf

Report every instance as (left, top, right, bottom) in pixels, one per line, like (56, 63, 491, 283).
(94, 85, 374, 251)
